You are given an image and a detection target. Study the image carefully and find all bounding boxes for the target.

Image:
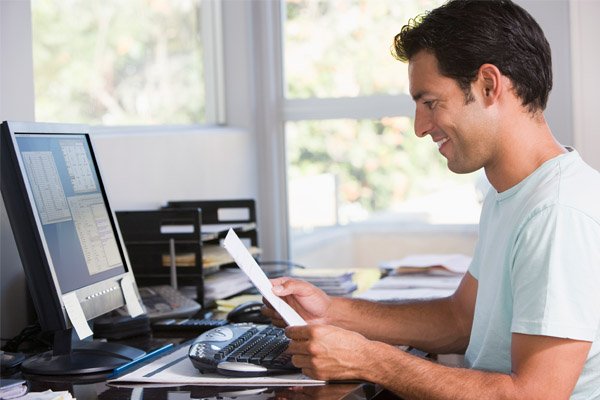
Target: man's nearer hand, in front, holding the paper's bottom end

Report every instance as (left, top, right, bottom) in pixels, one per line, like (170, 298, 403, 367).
(285, 325, 371, 381)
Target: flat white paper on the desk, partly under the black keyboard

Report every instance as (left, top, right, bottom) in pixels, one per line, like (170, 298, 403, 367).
(109, 345, 325, 386)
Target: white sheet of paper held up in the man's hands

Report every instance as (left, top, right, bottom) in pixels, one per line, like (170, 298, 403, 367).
(223, 229, 306, 326)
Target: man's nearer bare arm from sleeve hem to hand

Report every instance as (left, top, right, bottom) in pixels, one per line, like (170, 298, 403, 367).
(286, 325, 591, 400)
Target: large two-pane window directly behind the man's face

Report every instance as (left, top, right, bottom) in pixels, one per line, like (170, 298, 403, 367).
(283, 0, 480, 245)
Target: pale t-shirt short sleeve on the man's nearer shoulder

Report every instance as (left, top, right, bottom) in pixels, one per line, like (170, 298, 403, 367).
(510, 205, 600, 341)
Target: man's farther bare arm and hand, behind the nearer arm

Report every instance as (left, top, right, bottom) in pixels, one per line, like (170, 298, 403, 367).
(265, 273, 477, 354)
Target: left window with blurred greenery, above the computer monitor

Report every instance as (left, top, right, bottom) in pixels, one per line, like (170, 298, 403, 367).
(32, 0, 217, 125)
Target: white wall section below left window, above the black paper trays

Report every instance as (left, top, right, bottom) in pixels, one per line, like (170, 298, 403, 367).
(93, 127, 257, 210)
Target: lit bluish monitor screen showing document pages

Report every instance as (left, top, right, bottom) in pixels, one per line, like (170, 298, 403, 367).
(15, 133, 125, 293)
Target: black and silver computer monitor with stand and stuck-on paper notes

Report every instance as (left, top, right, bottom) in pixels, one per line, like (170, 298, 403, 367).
(0, 121, 144, 375)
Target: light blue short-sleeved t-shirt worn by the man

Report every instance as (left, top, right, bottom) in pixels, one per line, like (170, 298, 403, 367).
(465, 150, 600, 400)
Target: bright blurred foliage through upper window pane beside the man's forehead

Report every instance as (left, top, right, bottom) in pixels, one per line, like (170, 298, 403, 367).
(284, 0, 442, 98)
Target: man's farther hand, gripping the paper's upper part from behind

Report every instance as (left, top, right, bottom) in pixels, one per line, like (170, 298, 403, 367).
(262, 277, 331, 327)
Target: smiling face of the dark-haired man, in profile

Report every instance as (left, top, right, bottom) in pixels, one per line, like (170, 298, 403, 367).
(408, 51, 494, 173)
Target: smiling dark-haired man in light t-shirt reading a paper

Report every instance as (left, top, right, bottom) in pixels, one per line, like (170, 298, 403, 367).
(263, 0, 600, 399)
